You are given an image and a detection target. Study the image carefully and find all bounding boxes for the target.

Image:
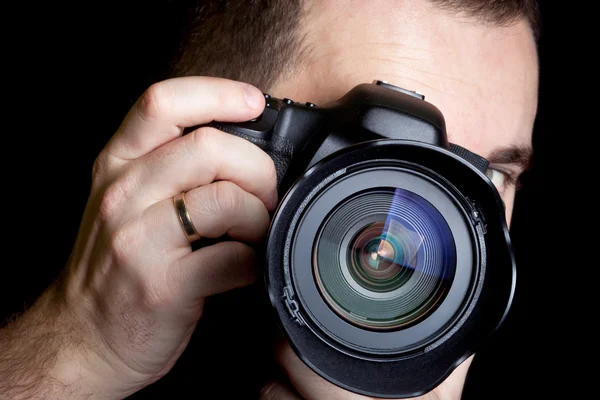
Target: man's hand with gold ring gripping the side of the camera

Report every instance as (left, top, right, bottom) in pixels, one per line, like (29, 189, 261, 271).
(0, 77, 277, 398)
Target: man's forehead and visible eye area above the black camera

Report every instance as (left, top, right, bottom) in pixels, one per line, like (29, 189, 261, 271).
(270, 1, 538, 225)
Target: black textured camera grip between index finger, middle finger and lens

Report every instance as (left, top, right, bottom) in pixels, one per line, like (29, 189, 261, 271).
(210, 122, 294, 187)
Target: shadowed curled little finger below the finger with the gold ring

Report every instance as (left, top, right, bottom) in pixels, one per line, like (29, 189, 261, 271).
(167, 242, 258, 303)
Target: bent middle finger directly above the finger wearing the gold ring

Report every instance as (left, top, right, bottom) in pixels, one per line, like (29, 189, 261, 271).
(131, 127, 277, 209)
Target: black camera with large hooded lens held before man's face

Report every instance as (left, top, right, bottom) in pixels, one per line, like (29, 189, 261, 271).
(211, 81, 516, 398)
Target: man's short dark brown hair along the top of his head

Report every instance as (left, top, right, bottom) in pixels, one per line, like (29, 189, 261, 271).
(170, 0, 539, 91)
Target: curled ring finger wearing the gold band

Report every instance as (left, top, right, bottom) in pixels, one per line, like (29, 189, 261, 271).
(144, 181, 269, 249)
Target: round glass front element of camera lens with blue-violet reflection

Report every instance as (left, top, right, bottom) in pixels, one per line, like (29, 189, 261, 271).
(313, 188, 456, 330)
